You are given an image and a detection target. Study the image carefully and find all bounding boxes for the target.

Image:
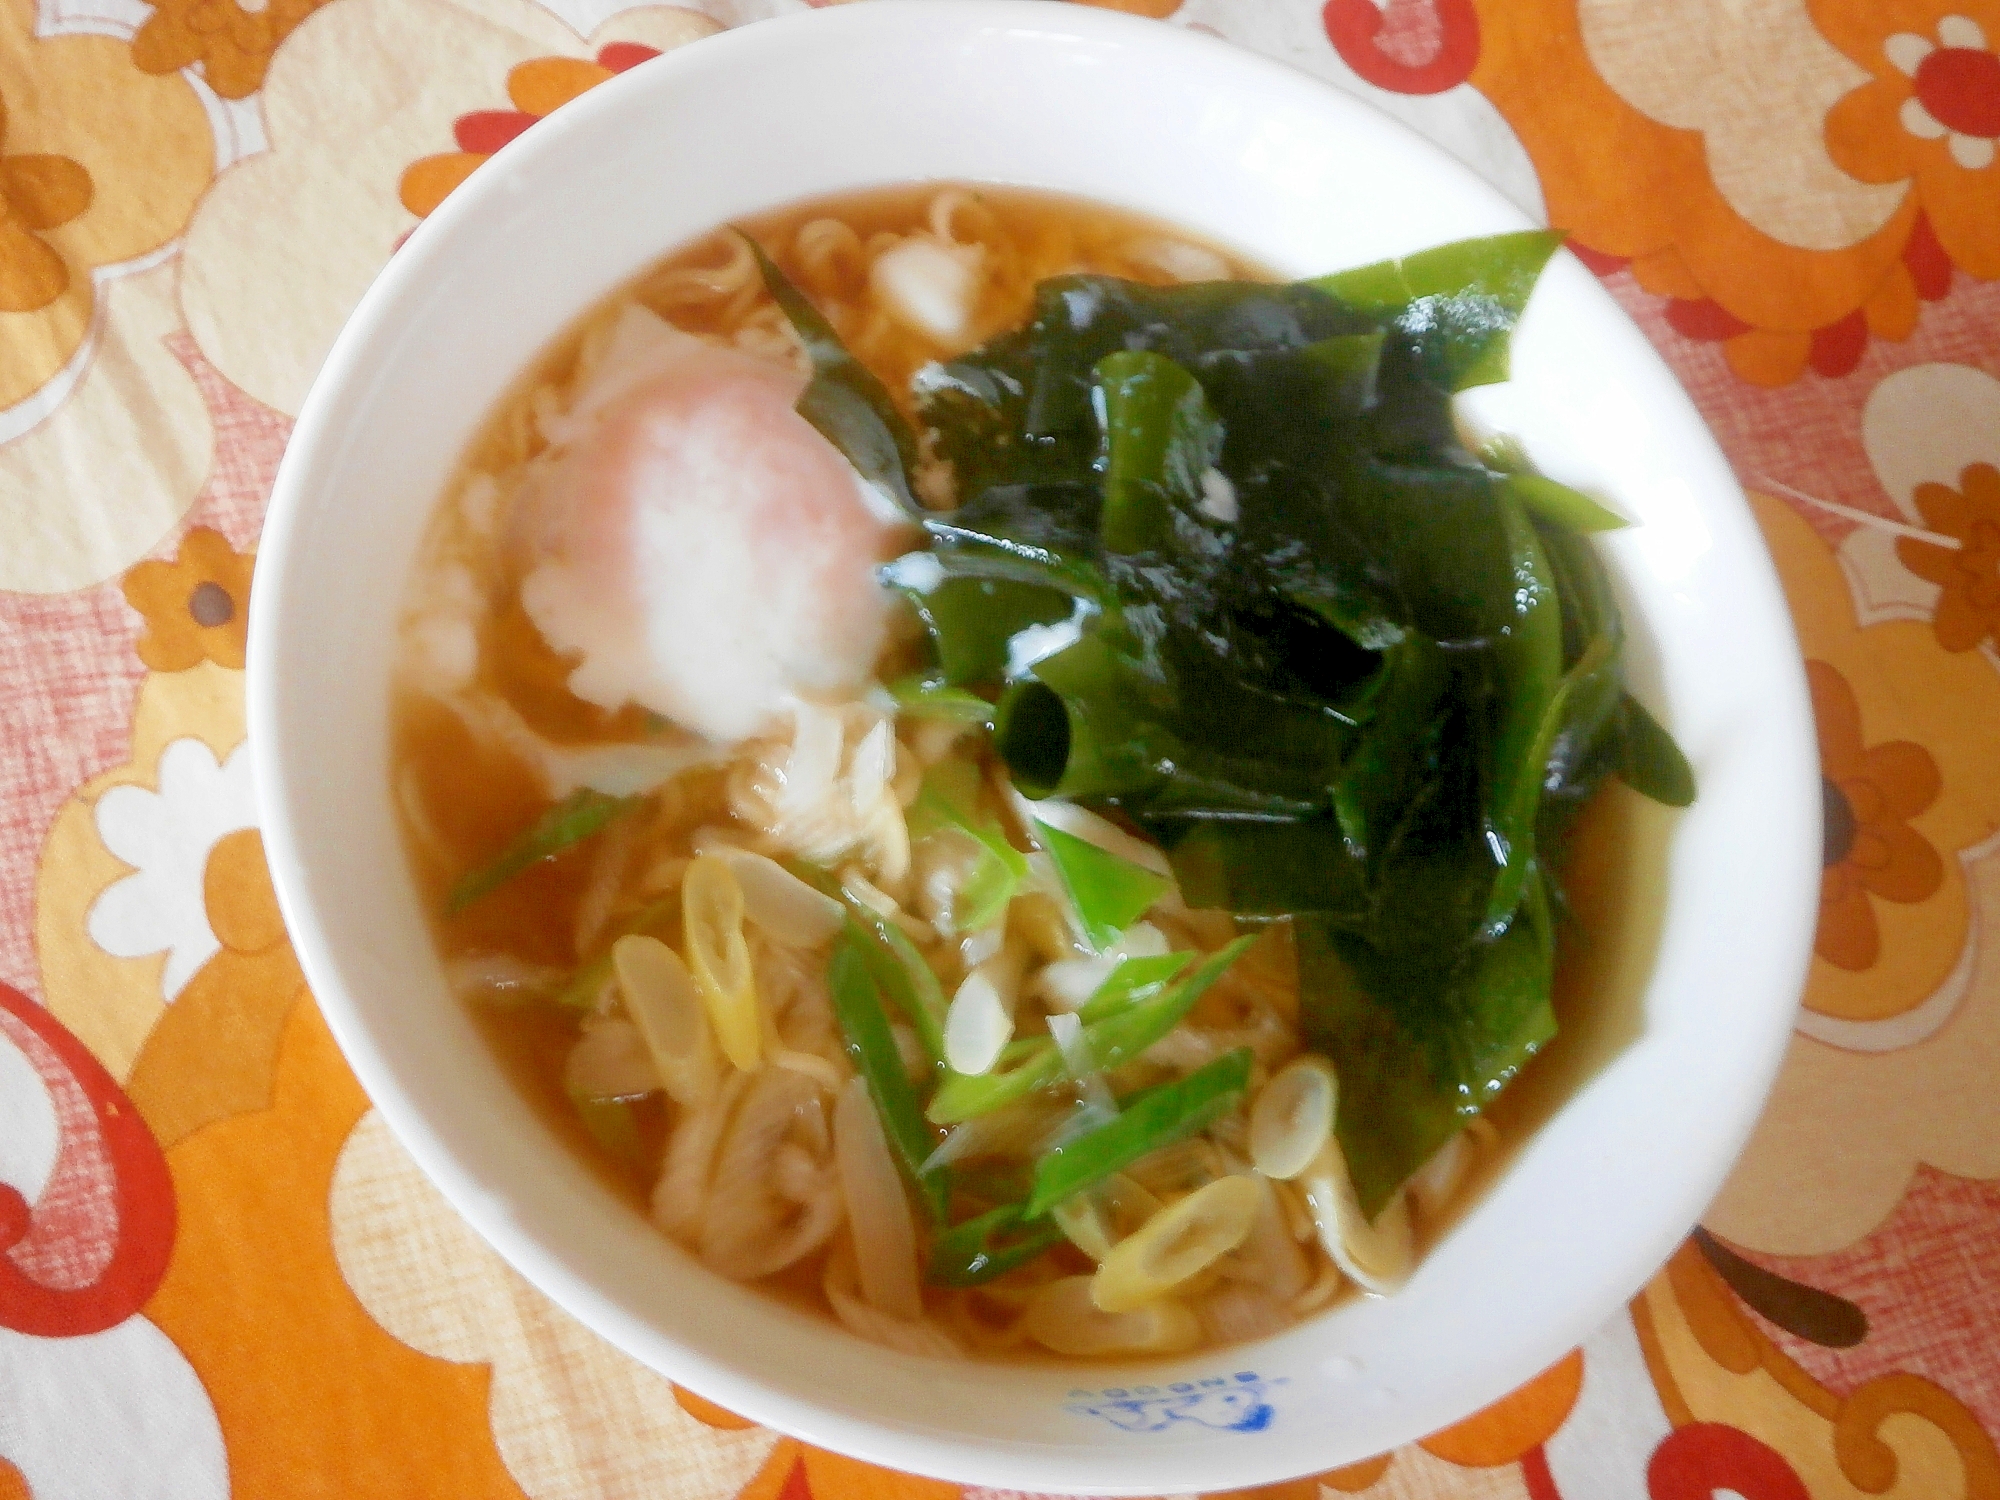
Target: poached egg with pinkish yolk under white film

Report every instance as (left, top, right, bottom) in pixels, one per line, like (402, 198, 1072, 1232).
(520, 328, 916, 742)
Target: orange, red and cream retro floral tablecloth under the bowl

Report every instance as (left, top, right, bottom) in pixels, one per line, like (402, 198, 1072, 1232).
(0, 0, 2000, 1500)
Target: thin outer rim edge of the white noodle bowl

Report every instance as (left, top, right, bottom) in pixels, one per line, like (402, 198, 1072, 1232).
(246, 0, 1818, 1494)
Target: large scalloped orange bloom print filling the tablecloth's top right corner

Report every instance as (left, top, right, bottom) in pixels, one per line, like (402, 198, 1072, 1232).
(1472, 0, 2000, 386)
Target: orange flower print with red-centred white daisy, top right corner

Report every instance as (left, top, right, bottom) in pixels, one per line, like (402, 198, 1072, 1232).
(1822, 0, 2000, 278)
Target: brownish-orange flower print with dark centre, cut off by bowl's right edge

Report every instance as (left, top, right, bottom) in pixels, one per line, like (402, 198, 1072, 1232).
(1806, 662, 1944, 970)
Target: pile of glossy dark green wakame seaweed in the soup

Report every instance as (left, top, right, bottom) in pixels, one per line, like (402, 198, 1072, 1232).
(766, 232, 1694, 1214)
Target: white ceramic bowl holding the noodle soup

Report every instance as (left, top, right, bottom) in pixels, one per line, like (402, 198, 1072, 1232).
(250, 0, 1820, 1494)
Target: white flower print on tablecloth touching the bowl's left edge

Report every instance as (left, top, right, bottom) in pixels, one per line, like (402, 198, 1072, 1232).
(88, 740, 256, 1000)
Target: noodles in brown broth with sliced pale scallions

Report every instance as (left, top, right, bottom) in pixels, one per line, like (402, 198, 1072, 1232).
(392, 186, 1656, 1356)
